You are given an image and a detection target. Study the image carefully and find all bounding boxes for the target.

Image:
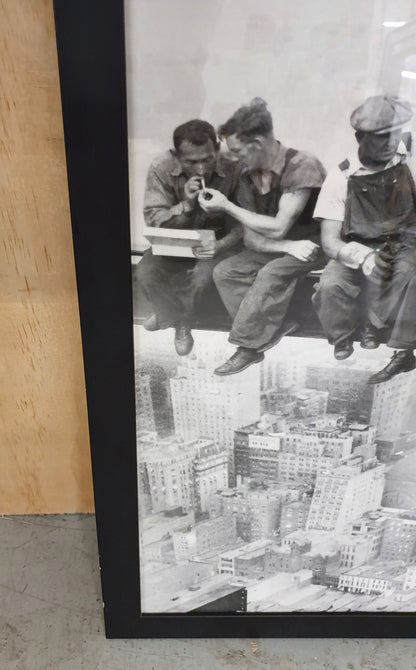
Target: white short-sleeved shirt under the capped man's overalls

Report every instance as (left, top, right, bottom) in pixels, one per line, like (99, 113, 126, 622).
(313, 142, 415, 221)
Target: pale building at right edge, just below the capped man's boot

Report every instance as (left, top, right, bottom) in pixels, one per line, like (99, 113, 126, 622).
(371, 371, 416, 438)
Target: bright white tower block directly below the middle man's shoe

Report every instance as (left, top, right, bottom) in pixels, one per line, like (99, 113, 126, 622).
(170, 357, 260, 452)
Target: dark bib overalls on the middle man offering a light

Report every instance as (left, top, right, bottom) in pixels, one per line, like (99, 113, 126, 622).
(214, 149, 325, 349)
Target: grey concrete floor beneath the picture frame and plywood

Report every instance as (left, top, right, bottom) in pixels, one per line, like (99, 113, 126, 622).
(0, 515, 416, 670)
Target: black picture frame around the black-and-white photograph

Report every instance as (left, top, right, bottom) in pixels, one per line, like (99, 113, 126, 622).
(54, 0, 414, 638)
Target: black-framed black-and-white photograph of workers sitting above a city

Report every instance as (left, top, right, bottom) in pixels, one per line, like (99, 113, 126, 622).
(54, 0, 416, 638)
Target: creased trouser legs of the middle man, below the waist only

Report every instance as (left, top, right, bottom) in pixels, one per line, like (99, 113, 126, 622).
(214, 249, 324, 349)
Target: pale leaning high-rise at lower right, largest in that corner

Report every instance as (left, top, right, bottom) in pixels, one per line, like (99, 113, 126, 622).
(306, 457, 385, 533)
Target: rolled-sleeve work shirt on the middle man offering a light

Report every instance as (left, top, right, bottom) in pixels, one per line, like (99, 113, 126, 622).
(235, 142, 326, 240)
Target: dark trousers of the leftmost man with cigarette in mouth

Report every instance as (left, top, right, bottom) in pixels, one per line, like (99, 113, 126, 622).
(133, 249, 233, 328)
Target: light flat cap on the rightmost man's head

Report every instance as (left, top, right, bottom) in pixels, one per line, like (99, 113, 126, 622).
(350, 95, 413, 135)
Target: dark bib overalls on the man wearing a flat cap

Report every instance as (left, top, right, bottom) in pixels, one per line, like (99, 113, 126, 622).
(313, 161, 416, 349)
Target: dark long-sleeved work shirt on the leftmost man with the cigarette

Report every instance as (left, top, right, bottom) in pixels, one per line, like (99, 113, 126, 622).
(143, 151, 236, 238)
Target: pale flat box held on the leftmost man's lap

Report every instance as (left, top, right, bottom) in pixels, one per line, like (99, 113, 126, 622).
(143, 226, 215, 258)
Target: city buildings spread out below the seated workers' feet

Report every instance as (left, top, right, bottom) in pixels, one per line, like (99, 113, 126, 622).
(134, 326, 416, 612)
